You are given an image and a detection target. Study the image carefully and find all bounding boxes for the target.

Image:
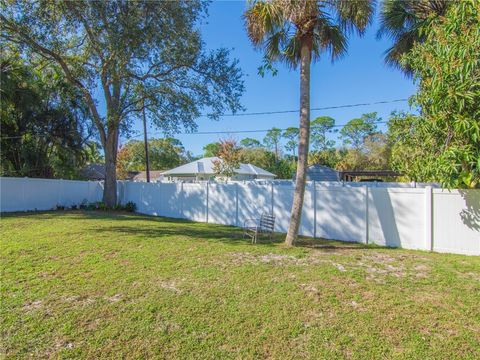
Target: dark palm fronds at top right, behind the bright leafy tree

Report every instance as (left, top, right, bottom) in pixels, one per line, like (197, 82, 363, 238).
(377, 0, 452, 75)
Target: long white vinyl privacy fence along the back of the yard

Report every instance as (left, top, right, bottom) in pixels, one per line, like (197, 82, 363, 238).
(0, 178, 480, 255)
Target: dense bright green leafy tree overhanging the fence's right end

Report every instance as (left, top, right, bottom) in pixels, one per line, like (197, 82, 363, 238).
(389, 0, 480, 188)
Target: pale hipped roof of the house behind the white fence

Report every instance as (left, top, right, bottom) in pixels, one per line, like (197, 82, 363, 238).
(163, 157, 276, 178)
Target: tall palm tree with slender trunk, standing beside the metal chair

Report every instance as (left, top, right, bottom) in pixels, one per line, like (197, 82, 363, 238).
(244, 0, 374, 245)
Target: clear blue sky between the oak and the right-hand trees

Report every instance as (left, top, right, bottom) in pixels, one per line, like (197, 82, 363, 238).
(121, 1, 415, 155)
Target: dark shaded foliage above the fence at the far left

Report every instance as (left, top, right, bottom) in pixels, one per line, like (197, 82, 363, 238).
(0, 48, 94, 179)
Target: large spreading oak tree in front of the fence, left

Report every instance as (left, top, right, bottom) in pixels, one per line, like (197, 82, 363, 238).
(0, 0, 243, 206)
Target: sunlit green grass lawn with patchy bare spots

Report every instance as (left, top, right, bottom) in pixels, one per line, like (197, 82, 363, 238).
(0, 212, 480, 359)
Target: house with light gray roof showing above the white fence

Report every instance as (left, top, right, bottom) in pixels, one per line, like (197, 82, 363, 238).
(162, 157, 276, 180)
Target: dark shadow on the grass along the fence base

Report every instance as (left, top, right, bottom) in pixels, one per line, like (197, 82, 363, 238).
(2, 210, 394, 252)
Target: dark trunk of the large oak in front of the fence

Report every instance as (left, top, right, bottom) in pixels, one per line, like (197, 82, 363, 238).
(103, 129, 118, 207)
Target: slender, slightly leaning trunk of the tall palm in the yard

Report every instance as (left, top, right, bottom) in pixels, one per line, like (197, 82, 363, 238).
(285, 38, 312, 246)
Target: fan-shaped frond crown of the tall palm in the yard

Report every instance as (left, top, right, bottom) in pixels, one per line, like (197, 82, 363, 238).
(244, 0, 374, 67)
